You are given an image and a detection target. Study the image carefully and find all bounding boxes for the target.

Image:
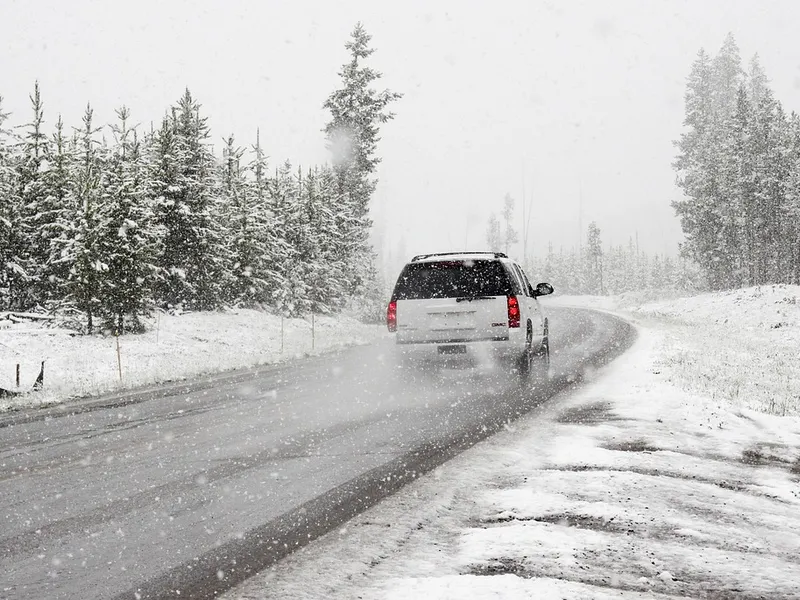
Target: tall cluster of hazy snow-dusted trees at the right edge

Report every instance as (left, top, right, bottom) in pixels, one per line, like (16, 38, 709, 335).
(674, 35, 800, 290)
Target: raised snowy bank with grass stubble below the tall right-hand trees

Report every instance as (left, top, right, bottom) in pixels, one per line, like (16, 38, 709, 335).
(549, 285, 800, 415)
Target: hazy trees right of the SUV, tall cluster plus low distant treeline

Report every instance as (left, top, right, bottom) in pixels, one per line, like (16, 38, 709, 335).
(520, 35, 800, 294)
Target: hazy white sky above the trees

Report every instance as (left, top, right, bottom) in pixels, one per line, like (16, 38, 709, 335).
(0, 0, 800, 274)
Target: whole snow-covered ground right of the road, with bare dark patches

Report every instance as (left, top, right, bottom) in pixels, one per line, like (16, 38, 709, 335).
(226, 286, 800, 600)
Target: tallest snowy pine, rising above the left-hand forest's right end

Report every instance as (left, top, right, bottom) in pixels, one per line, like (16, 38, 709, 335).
(323, 23, 401, 294)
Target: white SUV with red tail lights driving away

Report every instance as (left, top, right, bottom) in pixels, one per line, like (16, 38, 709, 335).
(386, 252, 553, 376)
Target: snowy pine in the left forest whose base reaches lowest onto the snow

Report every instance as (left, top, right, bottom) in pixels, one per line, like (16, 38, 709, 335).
(97, 106, 160, 335)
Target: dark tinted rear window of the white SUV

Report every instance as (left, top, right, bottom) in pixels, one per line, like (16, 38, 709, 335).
(393, 260, 514, 300)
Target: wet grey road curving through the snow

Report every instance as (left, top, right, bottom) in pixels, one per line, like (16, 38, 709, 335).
(0, 309, 633, 599)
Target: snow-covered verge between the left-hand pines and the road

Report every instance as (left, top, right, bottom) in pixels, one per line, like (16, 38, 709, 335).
(0, 310, 387, 410)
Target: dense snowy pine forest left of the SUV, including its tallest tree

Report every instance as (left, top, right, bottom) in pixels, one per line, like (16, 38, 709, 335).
(0, 24, 400, 333)
